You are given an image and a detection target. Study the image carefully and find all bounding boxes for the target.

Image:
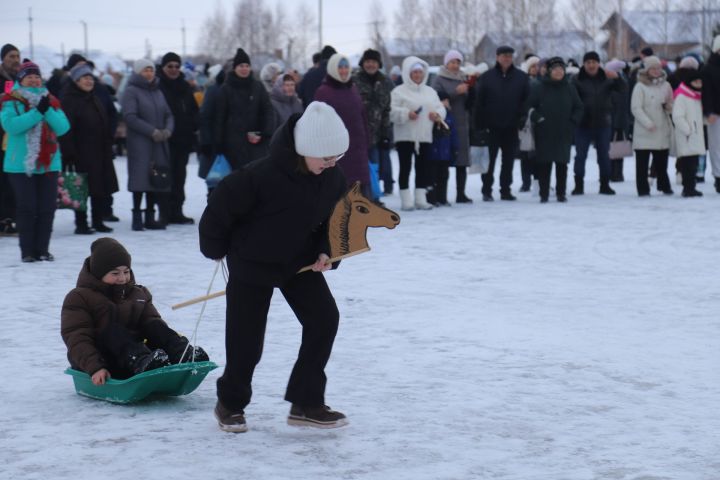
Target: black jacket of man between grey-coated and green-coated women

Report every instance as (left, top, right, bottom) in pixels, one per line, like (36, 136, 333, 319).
(475, 64, 530, 130)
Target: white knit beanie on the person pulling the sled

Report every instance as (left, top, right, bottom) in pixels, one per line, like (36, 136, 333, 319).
(294, 102, 350, 158)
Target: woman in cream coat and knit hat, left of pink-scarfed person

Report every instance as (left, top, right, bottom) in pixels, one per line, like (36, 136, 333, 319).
(630, 56, 673, 197)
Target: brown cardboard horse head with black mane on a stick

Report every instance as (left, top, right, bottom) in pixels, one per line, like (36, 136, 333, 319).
(328, 182, 400, 258)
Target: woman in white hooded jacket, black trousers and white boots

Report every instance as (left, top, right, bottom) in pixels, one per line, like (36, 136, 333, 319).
(390, 56, 446, 210)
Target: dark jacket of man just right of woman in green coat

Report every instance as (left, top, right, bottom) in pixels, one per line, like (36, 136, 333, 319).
(572, 67, 625, 128)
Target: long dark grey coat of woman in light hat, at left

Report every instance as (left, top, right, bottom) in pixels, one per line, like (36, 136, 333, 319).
(120, 73, 175, 192)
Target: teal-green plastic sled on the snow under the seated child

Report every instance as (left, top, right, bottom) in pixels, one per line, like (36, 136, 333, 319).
(65, 362, 217, 403)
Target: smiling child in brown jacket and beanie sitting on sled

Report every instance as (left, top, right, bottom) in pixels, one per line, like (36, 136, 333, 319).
(60, 237, 209, 385)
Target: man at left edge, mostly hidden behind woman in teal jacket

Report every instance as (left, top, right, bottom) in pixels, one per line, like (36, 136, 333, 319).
(0, 43, 20, 235)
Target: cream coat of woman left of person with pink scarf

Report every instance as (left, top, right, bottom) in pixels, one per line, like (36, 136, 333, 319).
(630, 70, 673, 150)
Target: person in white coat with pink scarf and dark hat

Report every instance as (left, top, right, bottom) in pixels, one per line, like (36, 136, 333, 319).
(673, 70, 707, 197)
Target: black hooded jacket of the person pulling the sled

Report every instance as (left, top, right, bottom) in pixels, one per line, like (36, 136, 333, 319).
(200, 114, 346, 287)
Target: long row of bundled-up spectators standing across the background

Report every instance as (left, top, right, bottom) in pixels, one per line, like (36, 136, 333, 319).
(0, 36, 720, 262)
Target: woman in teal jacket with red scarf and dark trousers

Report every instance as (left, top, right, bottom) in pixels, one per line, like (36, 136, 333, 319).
(0, 61, 70, 262)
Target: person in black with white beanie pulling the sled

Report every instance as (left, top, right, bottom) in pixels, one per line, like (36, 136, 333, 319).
(200, 102, 350, 432)
